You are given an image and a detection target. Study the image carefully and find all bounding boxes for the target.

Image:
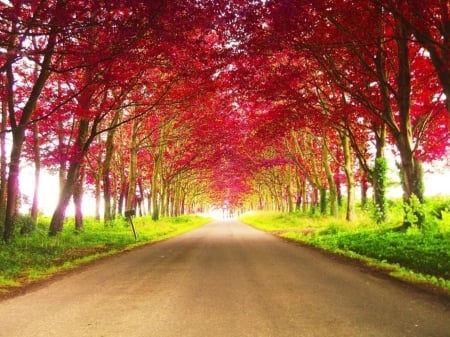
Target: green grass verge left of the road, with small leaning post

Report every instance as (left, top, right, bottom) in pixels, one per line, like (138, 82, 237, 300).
(0, 216, 211, 295)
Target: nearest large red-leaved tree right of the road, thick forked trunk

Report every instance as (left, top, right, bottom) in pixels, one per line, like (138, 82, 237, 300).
(256, 1, 448, 226)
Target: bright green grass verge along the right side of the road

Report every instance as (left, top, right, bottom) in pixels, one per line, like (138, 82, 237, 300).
(241, 199, 450, 295)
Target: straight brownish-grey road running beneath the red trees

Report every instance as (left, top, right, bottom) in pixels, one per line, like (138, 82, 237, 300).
(0, 221, 450, 337)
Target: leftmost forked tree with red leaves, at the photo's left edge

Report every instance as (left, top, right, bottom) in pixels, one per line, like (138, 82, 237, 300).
(0, 1, 61, 242)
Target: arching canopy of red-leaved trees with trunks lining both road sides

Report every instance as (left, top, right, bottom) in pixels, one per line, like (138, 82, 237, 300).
(0, 0, 450, 241)
